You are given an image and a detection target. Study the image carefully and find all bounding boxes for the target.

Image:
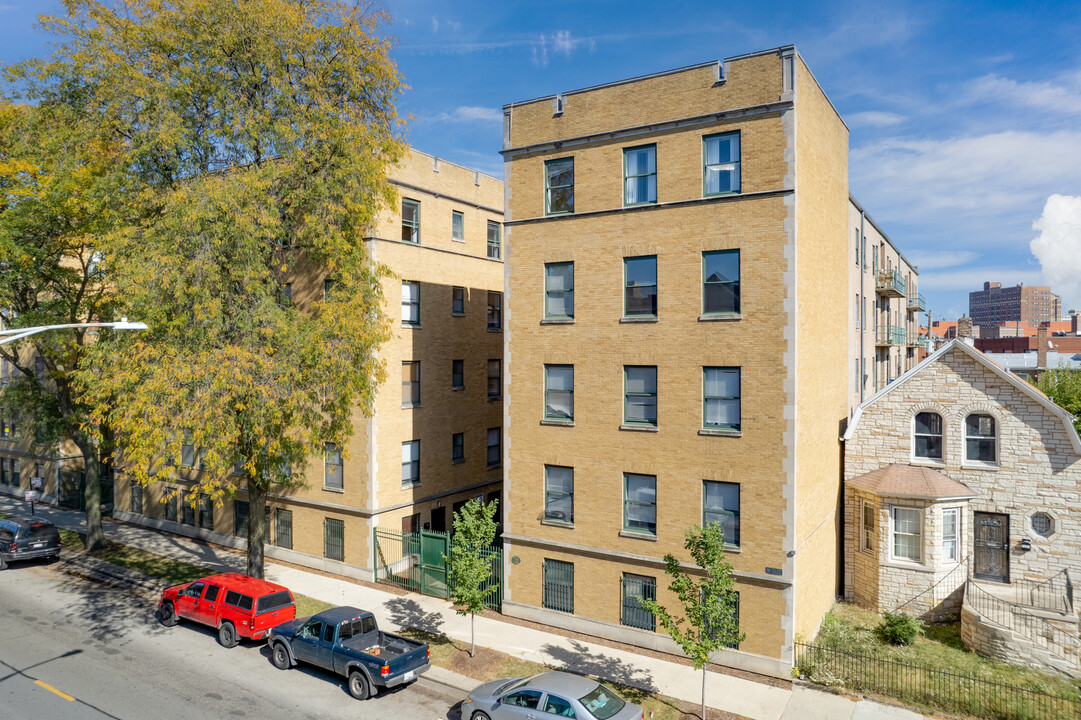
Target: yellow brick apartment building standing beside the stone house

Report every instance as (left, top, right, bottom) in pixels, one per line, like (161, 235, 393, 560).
(503, 46, 897, 677)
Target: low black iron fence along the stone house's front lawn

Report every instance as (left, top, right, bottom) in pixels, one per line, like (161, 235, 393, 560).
(796, 642, 1081, 720)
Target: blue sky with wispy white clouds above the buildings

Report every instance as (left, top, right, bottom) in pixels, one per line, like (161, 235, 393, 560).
(0, 0, 1081, 319)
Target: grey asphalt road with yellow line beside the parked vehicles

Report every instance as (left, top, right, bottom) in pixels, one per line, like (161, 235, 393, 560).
(0, 563, 461, 720)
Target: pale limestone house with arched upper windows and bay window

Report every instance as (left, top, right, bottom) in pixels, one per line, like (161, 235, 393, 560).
(843, 338, 1081, 671)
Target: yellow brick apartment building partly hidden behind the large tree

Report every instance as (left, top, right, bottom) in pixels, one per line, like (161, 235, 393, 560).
(115, 150, 504, 581)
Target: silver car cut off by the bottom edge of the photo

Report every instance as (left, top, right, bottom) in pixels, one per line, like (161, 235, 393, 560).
(462, 670, 645, 720)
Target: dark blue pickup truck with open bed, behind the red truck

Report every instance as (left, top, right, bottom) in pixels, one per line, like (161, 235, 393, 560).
(267, 608, 431, 699)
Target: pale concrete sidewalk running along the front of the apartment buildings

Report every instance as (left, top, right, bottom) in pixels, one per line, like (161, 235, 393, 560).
(0, 495, 923, 720)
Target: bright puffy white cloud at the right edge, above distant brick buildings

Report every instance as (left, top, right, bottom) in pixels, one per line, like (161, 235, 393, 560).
(1029, 195, 1081, 310)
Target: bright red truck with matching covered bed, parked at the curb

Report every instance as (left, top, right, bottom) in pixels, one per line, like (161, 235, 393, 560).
(158, 573, 296, 648)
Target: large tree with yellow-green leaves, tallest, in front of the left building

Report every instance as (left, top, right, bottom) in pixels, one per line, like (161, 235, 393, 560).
(11, 0, 403, 576)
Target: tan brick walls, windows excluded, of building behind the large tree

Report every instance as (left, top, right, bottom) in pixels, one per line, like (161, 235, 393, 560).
(117, 150, 504, 579)
